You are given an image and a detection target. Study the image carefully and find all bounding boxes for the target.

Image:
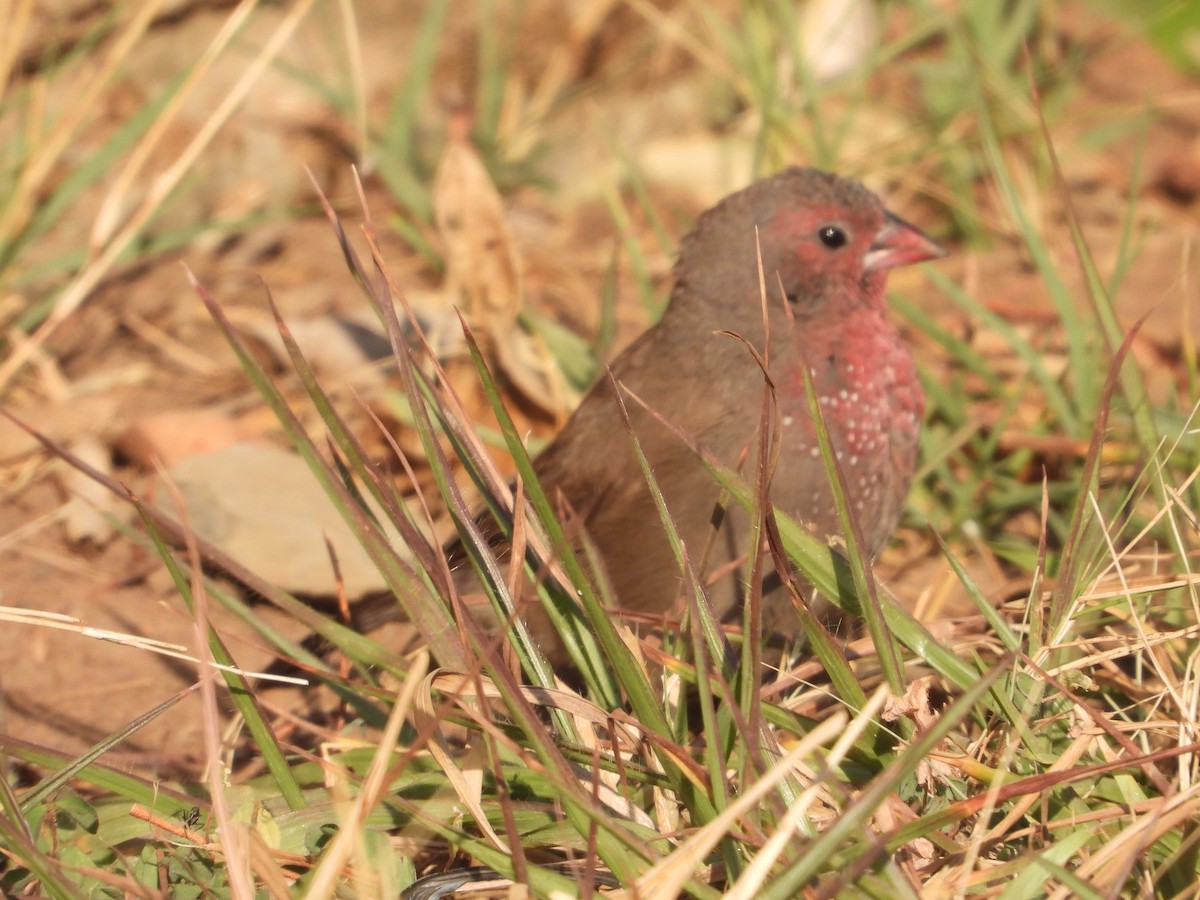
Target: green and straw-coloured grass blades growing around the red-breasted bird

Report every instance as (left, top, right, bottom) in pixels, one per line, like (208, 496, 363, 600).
(0, 0, 1200, 900)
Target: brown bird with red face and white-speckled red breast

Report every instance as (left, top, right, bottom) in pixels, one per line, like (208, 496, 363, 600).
(357, 167, 946, 665)
